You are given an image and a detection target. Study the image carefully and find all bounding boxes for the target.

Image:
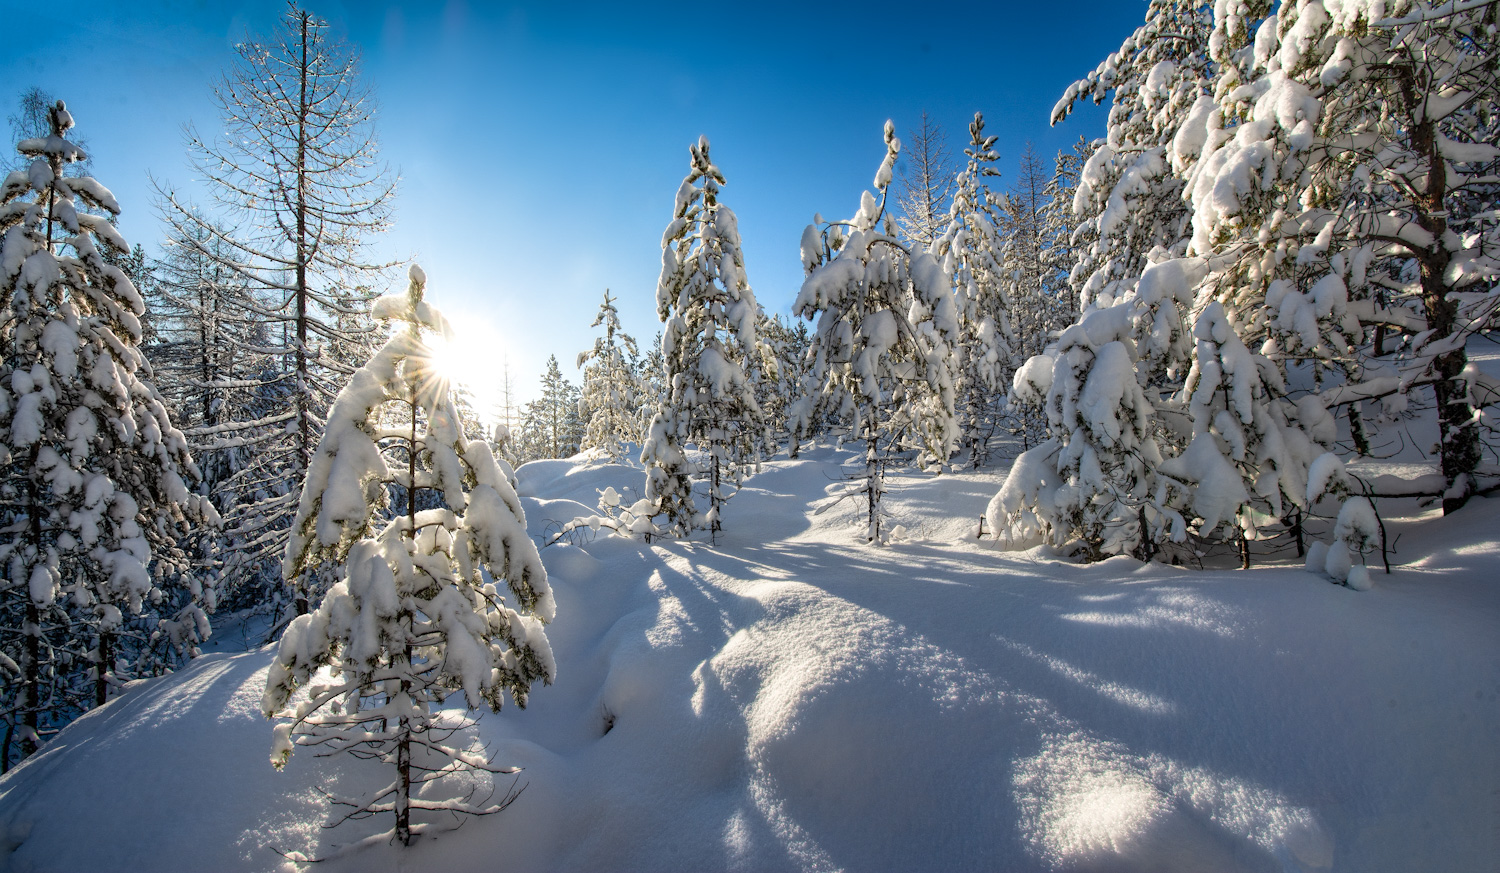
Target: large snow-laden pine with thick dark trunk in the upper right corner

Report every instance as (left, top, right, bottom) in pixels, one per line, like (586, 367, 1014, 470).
(1179, 0, 1500, 512)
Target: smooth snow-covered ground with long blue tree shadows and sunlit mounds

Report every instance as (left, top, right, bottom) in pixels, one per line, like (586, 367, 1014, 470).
(0, 449, 1500, 873)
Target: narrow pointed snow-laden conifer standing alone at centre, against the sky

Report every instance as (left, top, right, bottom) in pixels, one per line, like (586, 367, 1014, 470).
(641, 137, 767, 536)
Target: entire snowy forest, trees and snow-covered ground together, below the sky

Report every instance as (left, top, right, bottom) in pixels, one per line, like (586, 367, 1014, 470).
(0, 0, 1500, 870)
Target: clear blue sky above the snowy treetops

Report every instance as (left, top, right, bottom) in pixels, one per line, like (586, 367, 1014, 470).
(0, 0, 1146, 411)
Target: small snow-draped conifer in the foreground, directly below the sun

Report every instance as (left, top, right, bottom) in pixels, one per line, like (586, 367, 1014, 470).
(263, 267, 557, 845)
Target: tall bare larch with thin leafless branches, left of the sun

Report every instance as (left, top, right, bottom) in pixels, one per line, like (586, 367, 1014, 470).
(158, 6, 395, 614)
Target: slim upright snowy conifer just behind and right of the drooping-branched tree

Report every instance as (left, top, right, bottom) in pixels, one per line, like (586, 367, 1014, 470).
(932, 113, 1002, 468)
